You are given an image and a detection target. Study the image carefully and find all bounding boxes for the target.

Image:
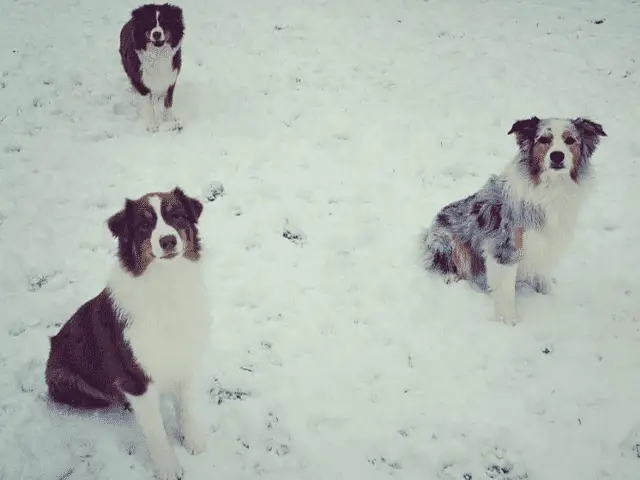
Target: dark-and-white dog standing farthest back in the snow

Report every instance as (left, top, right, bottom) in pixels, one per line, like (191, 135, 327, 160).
(120, 3, 184, 132)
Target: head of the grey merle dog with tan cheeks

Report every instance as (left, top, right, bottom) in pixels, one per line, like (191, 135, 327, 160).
(508, 117, 607, 184)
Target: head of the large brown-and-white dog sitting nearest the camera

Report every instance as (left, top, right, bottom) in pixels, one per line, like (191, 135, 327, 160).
(107, 187, 203, 276)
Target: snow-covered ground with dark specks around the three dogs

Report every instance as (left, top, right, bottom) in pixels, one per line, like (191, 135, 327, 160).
(0, 0, 640, 480)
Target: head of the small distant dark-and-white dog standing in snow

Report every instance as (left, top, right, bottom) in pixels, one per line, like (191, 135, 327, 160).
(131, 3, 184, 50)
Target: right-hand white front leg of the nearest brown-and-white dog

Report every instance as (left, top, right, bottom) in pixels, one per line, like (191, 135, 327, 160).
(176, 378, 206, 455)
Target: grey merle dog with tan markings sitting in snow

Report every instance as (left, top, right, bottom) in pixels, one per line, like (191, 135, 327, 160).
(422, 117, 606, 323)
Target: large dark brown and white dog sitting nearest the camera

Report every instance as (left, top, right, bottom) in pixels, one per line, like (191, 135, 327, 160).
(45, 187, 210, 480)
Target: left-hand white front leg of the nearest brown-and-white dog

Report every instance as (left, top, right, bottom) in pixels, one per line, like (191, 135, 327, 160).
(127, 384, 183, 480)
